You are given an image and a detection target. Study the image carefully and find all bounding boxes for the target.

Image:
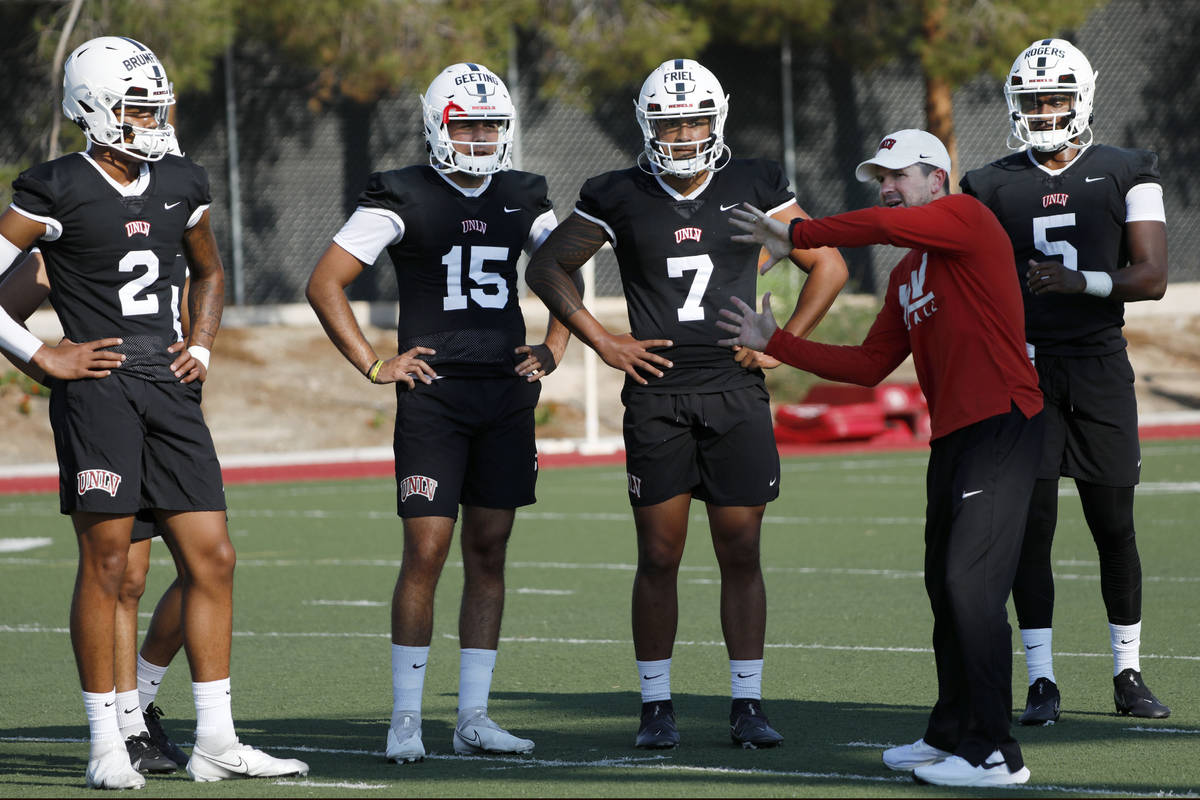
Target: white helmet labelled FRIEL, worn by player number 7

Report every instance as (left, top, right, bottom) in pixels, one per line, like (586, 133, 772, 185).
(634, 59, 730, 178)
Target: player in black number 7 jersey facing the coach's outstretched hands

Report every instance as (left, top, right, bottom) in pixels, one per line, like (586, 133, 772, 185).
(527, 59, 847, 748)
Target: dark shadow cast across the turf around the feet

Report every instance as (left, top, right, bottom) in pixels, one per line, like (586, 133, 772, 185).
(0, 692, 1184, 795)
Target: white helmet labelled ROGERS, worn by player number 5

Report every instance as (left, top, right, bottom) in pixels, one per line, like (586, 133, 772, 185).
(1004, 38, 1096, 152)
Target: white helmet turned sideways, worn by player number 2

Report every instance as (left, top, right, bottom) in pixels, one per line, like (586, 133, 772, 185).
(62, 36, 175, 161)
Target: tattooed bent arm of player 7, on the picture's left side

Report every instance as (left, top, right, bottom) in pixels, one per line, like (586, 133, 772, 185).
(526, 213, 671, 384)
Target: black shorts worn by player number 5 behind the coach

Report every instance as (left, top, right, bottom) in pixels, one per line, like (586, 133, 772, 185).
(1037, 350, 1141, 487)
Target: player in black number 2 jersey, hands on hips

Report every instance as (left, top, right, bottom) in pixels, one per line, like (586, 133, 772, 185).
(0, 36, 308, 788)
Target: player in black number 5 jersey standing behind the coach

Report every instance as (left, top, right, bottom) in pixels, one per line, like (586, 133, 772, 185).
(961, 38, 1171, 724)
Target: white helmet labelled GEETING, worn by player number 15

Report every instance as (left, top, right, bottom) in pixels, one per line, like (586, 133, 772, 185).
(421, 62, 516, 175)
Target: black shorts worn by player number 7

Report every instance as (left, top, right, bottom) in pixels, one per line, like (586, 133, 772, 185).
(622, 384, 779, 506)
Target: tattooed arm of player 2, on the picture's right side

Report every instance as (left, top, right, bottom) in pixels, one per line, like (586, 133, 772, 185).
(170, 211, 224, 384)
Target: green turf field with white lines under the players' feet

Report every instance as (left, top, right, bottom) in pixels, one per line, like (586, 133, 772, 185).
(0, 440, 1200, 798)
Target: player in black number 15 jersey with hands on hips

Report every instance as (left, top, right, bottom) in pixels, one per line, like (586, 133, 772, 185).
(307, 62, 568, 763)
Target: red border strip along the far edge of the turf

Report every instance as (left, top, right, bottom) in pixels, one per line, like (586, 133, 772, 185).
(7, 423, 1200, 494)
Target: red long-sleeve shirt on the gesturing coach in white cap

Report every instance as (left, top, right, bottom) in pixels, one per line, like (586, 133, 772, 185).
(767, 194, 1042, 439)
